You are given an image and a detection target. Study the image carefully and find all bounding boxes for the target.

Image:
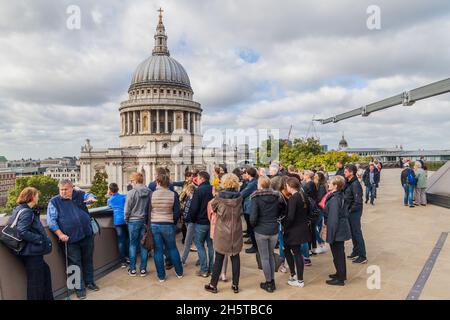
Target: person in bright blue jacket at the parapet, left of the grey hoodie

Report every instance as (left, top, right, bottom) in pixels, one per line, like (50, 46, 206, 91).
(108, 183, 129, 268)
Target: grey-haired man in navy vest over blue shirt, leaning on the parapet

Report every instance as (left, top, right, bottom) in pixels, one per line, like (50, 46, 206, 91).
(47, 179, 99, 299)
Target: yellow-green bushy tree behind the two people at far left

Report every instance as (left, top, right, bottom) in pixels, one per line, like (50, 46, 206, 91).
(6, 176, 59, 213)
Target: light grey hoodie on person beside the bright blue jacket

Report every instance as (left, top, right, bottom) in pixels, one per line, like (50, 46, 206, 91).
(125, 184, 151, 223)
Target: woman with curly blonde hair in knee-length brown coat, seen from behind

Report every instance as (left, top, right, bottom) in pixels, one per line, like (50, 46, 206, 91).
(205, 174, 243, 293)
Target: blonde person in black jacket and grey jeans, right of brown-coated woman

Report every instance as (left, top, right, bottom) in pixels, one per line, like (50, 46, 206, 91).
(250, 176, 284, 292)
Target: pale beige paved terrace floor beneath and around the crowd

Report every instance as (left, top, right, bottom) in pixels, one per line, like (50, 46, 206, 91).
(75, 169, 450, 300)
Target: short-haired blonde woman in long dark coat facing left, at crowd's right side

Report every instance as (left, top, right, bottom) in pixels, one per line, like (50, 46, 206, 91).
(322, 176, 351, 286)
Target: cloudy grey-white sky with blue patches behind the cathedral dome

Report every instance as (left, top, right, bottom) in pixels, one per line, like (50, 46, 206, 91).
(0, 0, 450, 159)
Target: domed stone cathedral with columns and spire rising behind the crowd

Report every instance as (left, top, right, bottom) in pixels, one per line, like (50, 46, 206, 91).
(79, 10, 204, 191)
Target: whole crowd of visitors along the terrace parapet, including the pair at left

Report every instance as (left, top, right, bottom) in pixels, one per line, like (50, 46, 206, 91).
(6, 162, 381, 299)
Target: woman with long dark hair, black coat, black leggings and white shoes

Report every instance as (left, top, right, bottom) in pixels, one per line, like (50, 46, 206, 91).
(283, 178, 311, 288)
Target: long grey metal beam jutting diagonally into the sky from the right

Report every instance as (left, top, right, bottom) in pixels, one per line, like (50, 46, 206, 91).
(315, 78, 450, 124)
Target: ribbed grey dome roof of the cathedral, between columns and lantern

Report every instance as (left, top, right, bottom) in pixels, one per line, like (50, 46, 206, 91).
(131, 54, 191, 89)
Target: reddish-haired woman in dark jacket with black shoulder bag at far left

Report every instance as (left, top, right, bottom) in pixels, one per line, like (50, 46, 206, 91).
(8, 187, 53, 300)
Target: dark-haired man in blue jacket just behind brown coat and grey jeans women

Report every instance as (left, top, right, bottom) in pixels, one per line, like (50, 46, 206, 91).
(241, 167, 258, 253)
